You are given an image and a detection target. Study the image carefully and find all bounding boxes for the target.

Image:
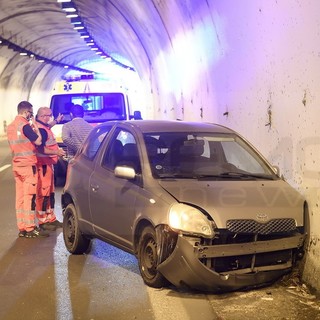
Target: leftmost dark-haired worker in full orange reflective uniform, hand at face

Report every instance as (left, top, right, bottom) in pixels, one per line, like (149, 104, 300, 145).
(7, 101, 49, 238)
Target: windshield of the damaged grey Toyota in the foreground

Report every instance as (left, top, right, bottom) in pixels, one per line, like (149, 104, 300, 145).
(144, 132, 278, 180)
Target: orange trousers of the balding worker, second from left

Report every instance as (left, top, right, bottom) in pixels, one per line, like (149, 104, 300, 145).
(36, 164, 57, 225)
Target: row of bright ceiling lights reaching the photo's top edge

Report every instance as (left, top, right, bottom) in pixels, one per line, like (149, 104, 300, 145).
(57, 0, 134, 71)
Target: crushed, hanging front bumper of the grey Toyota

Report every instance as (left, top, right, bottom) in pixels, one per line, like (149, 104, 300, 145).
(158, 234, 305, 292)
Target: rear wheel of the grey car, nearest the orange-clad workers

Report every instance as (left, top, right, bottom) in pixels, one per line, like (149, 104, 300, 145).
(63, 204, 91, 254)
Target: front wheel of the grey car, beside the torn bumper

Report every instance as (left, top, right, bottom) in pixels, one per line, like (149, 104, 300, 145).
(138, 226, 168, 288)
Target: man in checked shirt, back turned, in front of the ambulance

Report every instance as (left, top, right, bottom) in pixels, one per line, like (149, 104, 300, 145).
(62, 104, 92, 158)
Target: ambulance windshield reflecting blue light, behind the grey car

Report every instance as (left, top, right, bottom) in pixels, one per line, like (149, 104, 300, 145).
(50, 92, 127, 123)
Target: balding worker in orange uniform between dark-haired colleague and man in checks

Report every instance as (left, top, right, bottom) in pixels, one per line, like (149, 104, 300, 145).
(36, 107, 66, 230)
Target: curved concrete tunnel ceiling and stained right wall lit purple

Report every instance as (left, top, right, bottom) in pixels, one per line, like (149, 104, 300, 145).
(0, 0, 320, 290)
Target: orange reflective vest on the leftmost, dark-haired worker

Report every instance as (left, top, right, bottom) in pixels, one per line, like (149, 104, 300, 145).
(7, 115, 37, 167)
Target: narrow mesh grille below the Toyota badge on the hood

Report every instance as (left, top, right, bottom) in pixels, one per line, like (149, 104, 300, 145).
(227, 219, 296, 234)
